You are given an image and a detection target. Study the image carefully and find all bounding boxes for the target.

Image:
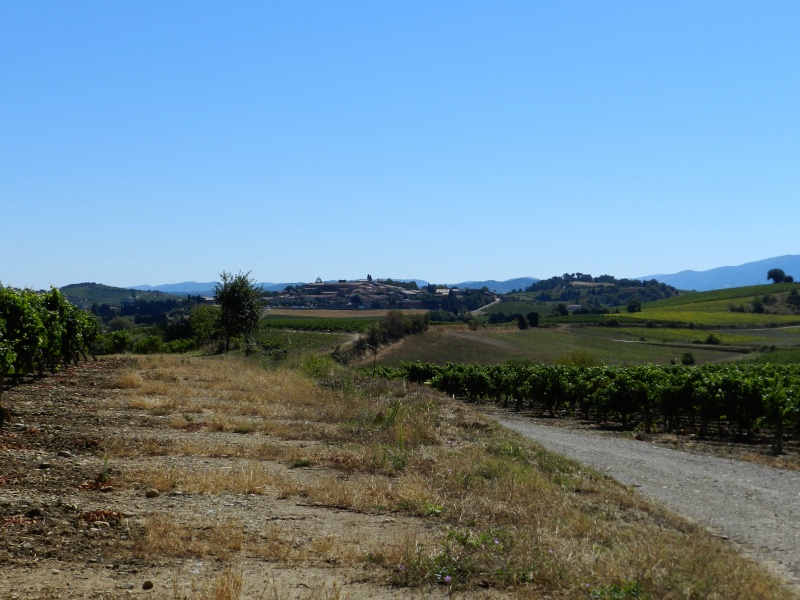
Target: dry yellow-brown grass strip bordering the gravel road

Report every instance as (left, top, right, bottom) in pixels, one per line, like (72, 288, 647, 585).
(109, 357, 783, 599)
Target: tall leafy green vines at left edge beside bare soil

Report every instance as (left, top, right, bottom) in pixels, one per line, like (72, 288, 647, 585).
(0, 286, 99, 393)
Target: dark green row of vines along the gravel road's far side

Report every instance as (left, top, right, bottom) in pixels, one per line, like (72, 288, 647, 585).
(375, 362, 800, 452)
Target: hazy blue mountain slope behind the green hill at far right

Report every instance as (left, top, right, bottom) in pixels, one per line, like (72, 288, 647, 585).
(636, 254, 800, 292)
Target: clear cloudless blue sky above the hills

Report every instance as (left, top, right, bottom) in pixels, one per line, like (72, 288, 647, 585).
(0, 0, 800, 288)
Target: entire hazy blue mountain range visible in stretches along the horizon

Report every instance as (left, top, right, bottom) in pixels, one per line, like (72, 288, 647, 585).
(130, 254, 800, 296)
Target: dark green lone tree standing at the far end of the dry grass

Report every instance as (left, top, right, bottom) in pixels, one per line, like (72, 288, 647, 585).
(214, 271, 261, 352)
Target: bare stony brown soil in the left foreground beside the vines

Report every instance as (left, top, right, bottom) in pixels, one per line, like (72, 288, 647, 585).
(0, 358, 462, 599)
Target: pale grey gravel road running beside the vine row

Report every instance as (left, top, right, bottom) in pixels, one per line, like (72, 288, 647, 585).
(490, 413, 800, 590)
